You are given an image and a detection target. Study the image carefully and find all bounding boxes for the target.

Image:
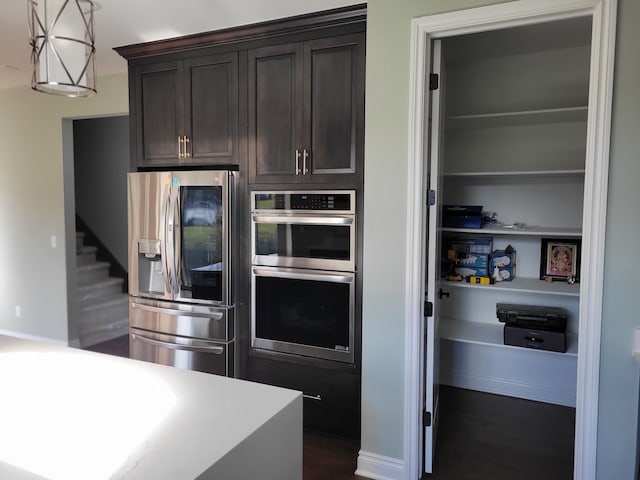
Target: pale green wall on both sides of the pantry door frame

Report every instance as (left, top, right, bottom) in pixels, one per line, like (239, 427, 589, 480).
(361, 0, 640, 480)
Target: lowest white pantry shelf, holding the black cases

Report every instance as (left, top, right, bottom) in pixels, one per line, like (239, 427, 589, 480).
(439, 318, 578, 357)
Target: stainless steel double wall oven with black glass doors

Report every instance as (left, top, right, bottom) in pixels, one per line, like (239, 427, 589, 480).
(251, 190, 356, 363)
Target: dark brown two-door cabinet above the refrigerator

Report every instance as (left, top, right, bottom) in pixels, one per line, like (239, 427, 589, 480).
(130, 52, 238, 167)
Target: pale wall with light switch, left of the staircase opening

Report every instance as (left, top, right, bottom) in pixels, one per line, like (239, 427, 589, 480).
(0, 74, 128, 343)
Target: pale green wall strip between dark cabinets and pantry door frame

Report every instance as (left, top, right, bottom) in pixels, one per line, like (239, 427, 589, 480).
(361, 0, 508, 459)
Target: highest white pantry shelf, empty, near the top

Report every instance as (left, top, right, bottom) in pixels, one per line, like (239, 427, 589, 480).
(445, 106, 588, 129)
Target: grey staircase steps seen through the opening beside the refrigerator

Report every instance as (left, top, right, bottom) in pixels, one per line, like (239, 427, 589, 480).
(76, 232, 129, 348)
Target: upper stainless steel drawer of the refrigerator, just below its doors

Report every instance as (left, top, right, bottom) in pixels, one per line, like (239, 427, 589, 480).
(129, 297, 235, 342)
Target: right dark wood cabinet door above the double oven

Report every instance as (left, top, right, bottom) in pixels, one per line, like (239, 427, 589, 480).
(303, 33, 364, 183)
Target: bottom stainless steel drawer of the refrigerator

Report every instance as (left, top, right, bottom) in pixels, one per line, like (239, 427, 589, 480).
(129, 328, 234, 376)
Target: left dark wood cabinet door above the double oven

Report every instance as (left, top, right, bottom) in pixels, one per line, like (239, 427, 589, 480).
(248, 43, 303, 183)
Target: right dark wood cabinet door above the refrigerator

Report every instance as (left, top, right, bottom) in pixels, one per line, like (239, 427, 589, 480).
(184, 52, 238, 165)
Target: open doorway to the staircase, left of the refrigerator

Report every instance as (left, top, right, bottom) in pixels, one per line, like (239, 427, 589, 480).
(64, 115, 130, 348)
